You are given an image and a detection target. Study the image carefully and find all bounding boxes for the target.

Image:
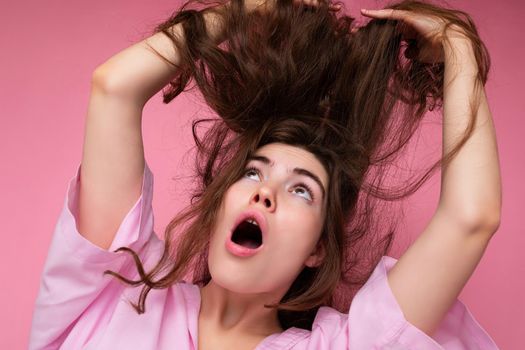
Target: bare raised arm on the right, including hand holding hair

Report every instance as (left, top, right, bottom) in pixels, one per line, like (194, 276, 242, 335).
(364, 10, 501, 335)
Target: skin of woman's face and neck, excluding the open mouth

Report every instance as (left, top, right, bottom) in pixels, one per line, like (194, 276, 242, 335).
(199, 143, 328, 348)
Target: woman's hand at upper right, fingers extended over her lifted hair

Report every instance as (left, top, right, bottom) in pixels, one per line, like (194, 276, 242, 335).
(361, 9, 458, 63)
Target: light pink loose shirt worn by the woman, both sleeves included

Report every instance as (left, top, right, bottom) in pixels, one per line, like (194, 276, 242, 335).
(29, 164, 497, 350)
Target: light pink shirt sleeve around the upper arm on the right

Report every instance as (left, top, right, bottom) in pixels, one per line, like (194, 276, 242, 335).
(348, 256, 498, 350)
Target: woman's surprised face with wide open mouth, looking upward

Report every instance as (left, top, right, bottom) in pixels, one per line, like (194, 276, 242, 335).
(208, 143, 328, 295)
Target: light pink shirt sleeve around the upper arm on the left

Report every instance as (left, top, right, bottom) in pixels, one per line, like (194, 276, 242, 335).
(29, 164, 160, 349)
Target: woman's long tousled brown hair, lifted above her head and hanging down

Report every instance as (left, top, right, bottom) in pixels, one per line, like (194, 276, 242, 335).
(105, 0, 490, 329)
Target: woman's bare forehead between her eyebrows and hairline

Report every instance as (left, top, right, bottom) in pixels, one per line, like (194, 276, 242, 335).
(251, 143, 328, 187)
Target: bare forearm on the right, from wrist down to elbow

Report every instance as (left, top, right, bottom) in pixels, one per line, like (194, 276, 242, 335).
(439, 32, 501, 228)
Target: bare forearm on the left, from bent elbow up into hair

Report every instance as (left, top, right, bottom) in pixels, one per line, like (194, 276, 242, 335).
(93, 3, 227, 106)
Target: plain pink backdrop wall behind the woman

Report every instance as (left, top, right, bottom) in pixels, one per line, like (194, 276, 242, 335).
(0, 0, 525, 349)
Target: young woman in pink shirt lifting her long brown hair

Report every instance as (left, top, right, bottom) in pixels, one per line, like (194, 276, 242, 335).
(30, 0, 501, 350)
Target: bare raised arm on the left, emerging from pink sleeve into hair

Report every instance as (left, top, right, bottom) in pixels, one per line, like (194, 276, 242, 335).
(77, 4, 226, 249)
